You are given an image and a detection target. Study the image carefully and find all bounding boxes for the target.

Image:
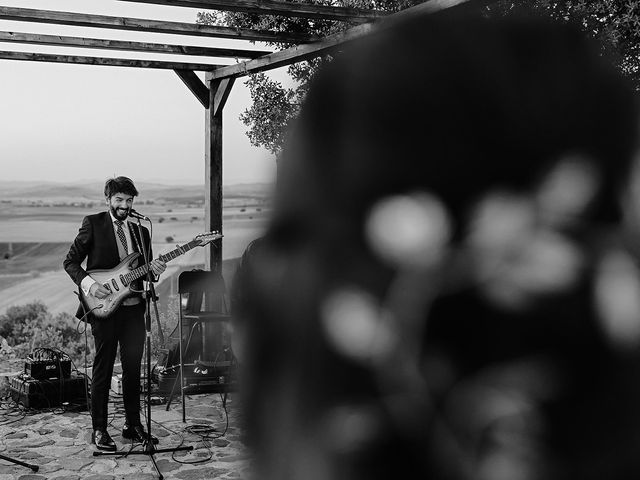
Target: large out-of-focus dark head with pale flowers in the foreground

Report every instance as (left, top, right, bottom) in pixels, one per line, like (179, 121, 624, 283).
(249, 6, 640, 480)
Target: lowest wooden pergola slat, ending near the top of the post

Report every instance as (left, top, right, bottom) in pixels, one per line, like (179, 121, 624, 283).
(0, 51, 218, 71)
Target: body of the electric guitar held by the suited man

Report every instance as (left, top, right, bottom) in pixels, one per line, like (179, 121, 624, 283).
(80, 252, 140, 318)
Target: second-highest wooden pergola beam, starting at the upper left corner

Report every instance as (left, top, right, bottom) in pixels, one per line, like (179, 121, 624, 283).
(0, 6, 319, 43)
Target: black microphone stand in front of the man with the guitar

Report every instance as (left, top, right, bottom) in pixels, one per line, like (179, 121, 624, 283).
(93, 217, 193, 480)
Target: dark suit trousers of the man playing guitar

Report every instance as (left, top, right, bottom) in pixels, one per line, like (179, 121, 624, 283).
(91, 301, 146, 430)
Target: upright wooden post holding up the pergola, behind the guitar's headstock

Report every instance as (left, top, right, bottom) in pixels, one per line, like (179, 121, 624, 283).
(204, 73, 233, 272)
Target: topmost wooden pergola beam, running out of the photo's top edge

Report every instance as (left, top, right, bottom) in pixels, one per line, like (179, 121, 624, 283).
(120, 0, 388, 23)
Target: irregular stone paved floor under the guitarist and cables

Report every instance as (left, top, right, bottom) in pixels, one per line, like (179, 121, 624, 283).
(0, 388, 248, 480)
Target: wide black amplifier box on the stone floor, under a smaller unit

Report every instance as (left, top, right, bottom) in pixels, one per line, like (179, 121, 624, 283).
(9, 376, 87, 408)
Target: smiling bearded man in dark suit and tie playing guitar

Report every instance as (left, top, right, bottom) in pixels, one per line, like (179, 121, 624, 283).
(63, 177, 166, 451)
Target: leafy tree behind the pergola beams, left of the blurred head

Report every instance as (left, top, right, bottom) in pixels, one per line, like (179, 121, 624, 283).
(197, 0, 422, 155)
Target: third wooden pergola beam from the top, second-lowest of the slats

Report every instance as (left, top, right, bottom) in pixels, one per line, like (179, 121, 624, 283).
(0, 31, 271, 58)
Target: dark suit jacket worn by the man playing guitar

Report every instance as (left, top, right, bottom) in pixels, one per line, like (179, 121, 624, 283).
(62, 212, 153, 318)
